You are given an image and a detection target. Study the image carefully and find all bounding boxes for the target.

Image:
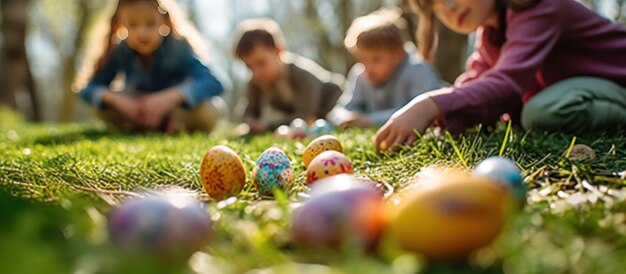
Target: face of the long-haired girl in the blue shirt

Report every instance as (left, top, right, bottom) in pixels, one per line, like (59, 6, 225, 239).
(120, 1, 165, 55)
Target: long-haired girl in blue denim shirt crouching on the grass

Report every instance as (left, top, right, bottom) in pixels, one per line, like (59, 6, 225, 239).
(79, 0, 223, 132)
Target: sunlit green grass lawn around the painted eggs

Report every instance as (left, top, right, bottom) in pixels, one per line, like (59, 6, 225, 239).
(0, 112, 626, 273)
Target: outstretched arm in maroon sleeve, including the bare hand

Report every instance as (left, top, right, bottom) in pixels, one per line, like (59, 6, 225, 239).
(375, 4, 561, 150)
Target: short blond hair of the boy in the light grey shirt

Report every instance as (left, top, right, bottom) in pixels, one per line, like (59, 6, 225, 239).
(343, 9, 405, 53)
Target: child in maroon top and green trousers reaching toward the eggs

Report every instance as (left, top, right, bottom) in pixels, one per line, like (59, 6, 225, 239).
(376, 0, 626, 150)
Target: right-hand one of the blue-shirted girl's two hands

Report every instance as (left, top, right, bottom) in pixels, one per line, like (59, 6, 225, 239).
(141, 89, 184, 128)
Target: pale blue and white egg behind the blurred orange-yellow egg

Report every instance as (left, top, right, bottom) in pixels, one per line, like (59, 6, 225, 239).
(472, 157, 526, 200)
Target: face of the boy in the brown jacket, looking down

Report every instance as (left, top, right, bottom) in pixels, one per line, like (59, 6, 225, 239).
(240, 45, 282, 86)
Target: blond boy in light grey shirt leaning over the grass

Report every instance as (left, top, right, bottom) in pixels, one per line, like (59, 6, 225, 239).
(333, 10, 441, 128)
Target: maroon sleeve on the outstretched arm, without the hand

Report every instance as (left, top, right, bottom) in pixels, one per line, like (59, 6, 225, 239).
(431, 1, 561, 131)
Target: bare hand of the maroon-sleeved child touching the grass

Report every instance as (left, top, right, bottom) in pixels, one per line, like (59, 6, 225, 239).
(375, 96, 440, 152)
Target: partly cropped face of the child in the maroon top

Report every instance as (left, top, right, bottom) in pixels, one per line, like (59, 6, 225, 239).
(433, 0, 497, 34)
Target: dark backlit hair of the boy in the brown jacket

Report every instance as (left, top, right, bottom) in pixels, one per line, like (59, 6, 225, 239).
(233, 18, 285, 58)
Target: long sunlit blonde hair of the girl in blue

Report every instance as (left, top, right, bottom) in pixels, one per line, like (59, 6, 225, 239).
(72, 0, 210, 92)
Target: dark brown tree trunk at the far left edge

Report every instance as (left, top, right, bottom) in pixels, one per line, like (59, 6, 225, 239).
(0, 0, 41, 121)
